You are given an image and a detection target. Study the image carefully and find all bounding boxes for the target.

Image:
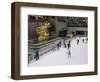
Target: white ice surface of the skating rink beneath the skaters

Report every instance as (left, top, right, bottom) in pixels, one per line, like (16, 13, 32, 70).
(29, 37, 88, 66)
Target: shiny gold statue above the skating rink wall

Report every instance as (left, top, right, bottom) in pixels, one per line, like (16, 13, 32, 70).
(36, 21, 50, 42)
